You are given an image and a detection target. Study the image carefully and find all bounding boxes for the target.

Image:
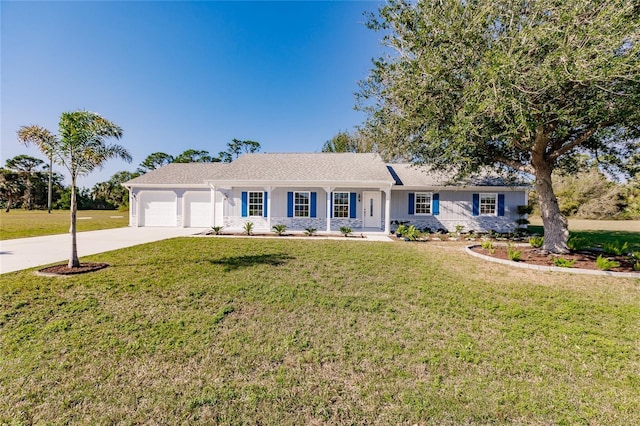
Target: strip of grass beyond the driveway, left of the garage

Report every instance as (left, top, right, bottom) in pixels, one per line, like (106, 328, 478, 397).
(0, 210, 129, 240)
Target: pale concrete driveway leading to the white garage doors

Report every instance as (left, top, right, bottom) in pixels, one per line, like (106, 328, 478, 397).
(0, 227, 205, 274)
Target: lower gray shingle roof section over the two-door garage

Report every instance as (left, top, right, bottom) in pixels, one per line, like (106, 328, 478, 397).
(125, 163, 229, 186)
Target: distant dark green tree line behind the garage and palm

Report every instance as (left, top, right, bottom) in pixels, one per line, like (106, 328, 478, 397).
(0, 139, 261, 212)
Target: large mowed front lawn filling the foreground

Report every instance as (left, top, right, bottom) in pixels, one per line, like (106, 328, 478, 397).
(0, 238, 640, 425)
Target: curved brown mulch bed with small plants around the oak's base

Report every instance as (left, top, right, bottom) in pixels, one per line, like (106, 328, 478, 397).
(472, 246, 637, 272)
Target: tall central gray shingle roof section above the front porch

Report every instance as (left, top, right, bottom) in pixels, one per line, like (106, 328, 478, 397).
(212, 153, 393, 184)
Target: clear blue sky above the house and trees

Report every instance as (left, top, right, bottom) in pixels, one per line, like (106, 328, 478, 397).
(0, 1, 382, 187)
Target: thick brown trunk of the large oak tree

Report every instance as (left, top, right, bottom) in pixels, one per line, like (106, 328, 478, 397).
(532, 154, 569, 254)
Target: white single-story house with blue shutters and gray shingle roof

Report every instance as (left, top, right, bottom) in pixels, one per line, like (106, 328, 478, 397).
(124, 153, 528, 233)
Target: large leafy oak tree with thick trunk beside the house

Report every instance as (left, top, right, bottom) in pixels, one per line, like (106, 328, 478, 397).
(357, 0, 640, 253)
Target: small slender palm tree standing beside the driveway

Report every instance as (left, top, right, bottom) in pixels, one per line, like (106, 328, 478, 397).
(19, 111, 131, 268)
